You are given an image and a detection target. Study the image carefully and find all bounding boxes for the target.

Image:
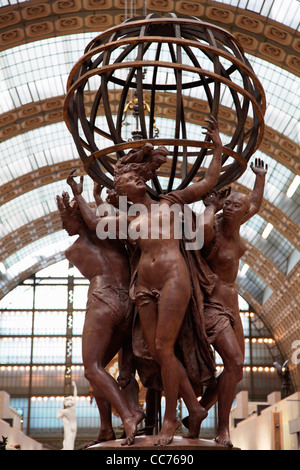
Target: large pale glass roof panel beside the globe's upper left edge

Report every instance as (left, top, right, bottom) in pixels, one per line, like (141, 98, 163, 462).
(0, 33, 95, 113)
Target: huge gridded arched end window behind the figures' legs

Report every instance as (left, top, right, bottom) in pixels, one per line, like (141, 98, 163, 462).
(0, 260, 280, 444)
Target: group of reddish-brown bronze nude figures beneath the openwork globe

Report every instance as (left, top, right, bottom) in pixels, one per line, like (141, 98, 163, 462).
(57, 117, 267, 447)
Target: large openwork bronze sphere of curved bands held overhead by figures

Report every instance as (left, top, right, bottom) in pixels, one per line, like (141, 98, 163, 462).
(64, 13, 266, 199)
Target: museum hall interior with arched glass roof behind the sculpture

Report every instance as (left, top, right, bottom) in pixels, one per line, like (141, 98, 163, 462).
(0, 0, 300, 450)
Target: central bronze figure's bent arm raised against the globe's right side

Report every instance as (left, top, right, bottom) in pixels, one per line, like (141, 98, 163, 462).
(177, 116, 222, 204)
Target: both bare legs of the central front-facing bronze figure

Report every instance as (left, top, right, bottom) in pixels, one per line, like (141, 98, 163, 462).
(139, 283, 207, 445)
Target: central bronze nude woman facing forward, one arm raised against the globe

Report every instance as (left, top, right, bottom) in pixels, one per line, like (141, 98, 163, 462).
(106, 117, 222, 445)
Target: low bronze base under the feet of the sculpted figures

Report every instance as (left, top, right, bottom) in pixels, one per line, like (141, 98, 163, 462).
(86, 436, 239, 452)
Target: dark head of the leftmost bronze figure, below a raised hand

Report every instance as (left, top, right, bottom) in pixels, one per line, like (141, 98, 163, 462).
(56, 192, 84, 236)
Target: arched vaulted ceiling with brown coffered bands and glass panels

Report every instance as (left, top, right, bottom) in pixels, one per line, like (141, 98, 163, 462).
(0, 0, 300, 380)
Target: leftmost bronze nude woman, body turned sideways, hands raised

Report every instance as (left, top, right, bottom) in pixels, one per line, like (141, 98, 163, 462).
(57, 182, 144, 445)
